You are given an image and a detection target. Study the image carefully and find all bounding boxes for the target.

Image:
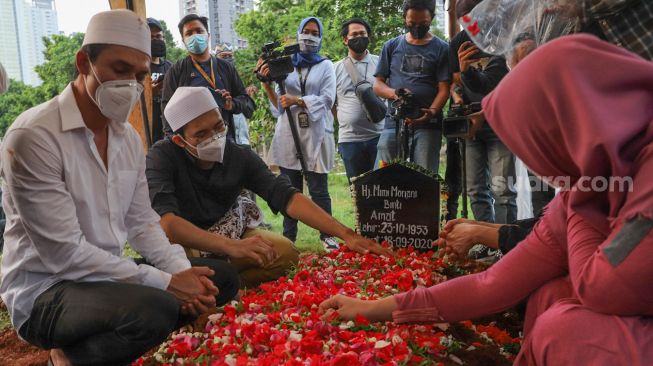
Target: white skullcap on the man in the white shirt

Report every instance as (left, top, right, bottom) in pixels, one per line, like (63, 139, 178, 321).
(82, 9, 152, 56)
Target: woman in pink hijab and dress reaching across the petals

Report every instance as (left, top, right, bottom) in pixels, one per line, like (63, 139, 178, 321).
(320, 35, 653, 366)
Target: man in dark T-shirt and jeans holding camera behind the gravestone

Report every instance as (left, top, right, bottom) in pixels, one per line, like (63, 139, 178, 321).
(374, 0, 449, 172)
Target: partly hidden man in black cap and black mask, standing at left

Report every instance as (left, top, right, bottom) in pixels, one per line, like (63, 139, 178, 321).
(147, 18, 172, 143)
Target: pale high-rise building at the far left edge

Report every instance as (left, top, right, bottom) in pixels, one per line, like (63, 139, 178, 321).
(0, 0, 59, 85)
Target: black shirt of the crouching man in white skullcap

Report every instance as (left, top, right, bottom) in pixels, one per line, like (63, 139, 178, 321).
(145, 139, 299, 230)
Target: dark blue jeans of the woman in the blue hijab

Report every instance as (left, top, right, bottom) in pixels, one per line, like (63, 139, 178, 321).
(279, 167, 331, 242)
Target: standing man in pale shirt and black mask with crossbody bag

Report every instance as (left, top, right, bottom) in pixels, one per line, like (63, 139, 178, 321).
(334, 18, 383, 182)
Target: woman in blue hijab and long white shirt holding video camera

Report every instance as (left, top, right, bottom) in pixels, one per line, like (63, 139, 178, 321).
(257, 17, 338, 250)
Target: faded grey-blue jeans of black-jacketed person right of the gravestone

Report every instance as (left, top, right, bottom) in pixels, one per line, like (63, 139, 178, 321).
(466, 124, 517, 224)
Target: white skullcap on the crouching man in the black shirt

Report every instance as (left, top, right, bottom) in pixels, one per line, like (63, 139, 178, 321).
(163, 86, 218, 132)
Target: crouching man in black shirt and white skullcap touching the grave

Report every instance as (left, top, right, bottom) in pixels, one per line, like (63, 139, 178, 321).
(146, 87, 388, 288)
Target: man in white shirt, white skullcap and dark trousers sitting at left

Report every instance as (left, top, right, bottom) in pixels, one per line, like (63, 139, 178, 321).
(0, 10, 239, 365)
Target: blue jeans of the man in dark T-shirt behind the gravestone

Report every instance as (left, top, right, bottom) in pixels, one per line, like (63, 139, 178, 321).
(374, 128, 442, 172)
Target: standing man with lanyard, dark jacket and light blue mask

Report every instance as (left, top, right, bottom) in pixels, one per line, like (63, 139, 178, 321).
(161, 14, 256, 140)
